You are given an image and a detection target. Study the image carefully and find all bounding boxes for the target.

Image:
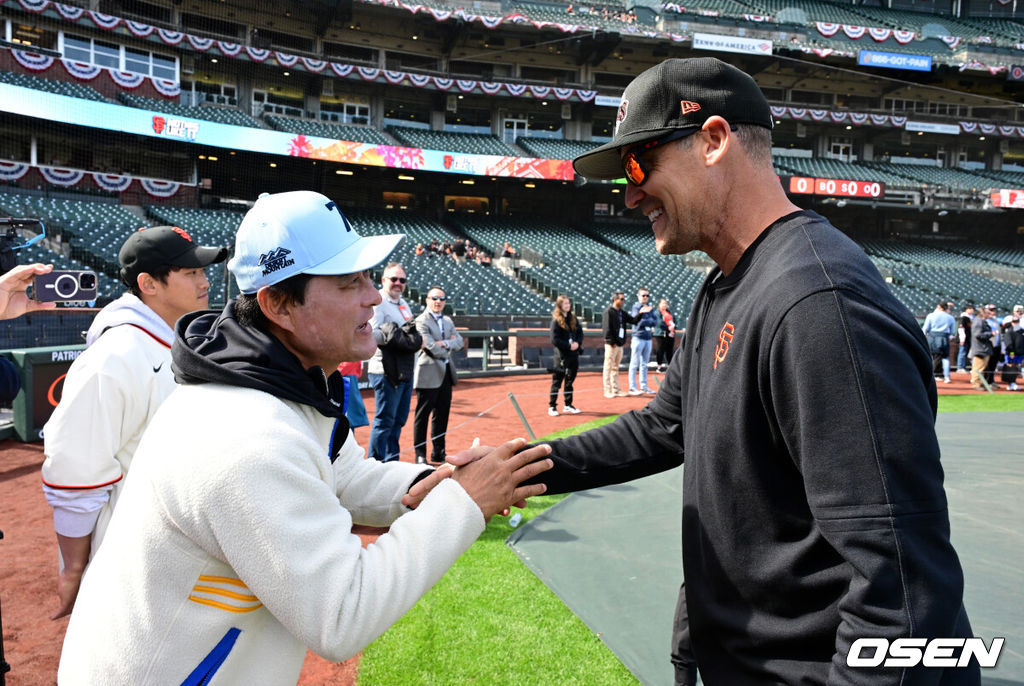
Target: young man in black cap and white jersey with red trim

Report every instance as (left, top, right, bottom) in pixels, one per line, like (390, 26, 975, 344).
(43, 226, 227, 618)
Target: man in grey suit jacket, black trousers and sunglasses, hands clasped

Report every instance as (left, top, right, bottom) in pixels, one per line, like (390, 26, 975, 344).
(413, 286, 463, 464)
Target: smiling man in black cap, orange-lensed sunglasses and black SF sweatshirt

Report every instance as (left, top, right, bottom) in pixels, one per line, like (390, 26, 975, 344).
(520, 57, 979, 686)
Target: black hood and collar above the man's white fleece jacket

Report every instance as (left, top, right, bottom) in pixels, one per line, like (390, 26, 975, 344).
(171, 300, 348, 423)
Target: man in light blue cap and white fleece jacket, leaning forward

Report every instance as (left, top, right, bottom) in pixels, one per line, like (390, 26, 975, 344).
(57, 190, 551, 686)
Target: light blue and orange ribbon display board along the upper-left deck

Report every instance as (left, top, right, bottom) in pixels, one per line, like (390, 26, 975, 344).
(0, 83, 572, 181)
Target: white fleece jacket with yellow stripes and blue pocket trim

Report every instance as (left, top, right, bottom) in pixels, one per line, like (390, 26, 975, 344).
(57, 384, 484, 686)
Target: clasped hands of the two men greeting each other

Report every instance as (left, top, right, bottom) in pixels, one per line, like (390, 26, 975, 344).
(401, 438, 554, 521)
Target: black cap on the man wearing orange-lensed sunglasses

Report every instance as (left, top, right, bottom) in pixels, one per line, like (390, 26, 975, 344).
(572, 57, 772, 179)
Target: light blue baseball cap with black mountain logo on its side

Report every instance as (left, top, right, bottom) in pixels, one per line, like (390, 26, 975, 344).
(227, 190, 406, 294)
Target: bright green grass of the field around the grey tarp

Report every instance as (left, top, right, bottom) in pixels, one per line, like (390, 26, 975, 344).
(358, 393, 1024, 686)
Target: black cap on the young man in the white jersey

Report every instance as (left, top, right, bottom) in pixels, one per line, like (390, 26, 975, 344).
(118, 226, 227, 286)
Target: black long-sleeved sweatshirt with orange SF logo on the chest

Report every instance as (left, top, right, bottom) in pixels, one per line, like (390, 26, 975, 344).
(538, 212, 979, 686)
